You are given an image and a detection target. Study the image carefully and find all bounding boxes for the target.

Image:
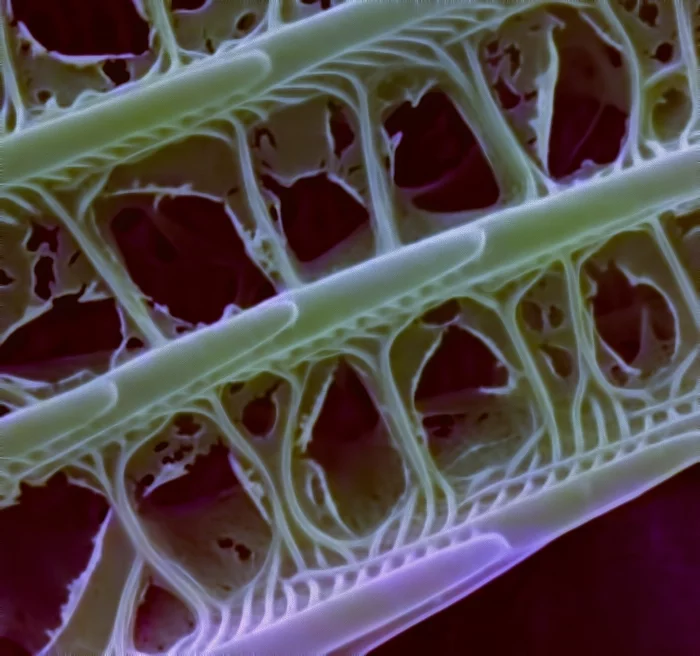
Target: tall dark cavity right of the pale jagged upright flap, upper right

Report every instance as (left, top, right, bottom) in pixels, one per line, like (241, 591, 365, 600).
(547, 8, 630, 180)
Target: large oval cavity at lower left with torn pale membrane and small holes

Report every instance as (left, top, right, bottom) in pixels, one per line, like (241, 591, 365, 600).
(127, 415, 272, 598)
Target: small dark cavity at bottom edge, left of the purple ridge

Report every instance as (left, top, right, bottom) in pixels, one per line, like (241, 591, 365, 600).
(133, 581, 195, 654)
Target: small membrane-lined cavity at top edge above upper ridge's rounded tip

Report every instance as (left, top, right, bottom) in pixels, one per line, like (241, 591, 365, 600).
(170, 0, 267, 55)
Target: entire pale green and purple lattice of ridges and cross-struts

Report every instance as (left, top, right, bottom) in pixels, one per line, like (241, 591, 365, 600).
(0, 0, 700, 656)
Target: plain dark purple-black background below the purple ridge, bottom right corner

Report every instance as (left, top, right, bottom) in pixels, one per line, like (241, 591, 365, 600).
(371, 465, 700, 656)
